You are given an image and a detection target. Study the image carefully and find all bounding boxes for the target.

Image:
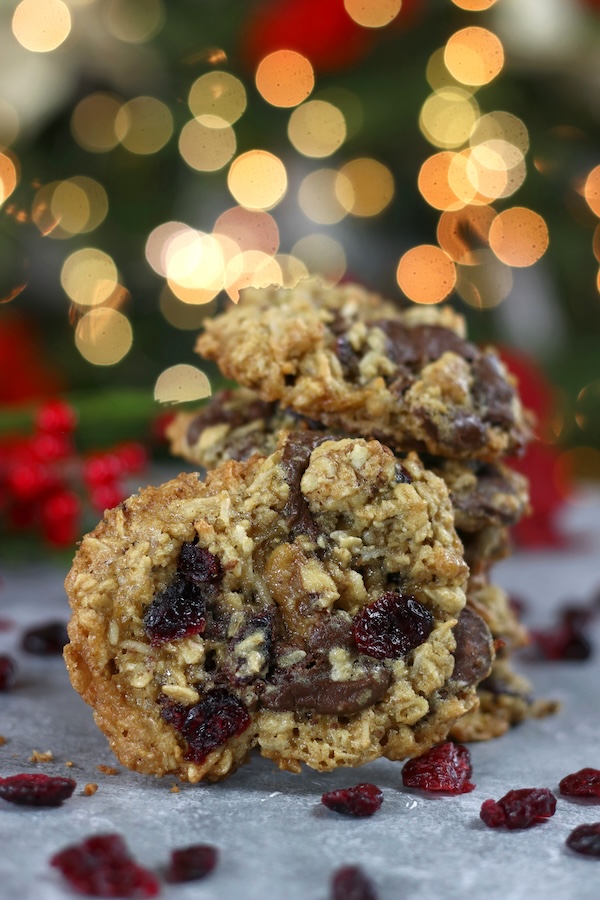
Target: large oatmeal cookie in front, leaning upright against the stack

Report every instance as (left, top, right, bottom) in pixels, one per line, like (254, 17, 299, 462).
(65, 432, 493, 782)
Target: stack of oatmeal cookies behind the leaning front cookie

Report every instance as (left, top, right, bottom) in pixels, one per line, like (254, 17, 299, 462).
(168, 282, 551, 740)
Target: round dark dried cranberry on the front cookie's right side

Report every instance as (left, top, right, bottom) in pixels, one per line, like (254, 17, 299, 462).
(352, 591, 433, 659)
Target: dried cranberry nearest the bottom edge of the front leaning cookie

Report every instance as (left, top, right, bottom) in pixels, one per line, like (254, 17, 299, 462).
(162, 688, 251, 764)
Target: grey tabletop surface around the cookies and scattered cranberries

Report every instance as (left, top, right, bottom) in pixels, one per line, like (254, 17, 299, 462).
(0, 495, 600, 900)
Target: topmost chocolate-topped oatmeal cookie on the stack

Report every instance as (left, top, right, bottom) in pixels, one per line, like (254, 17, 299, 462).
(196, 281, 529, 461)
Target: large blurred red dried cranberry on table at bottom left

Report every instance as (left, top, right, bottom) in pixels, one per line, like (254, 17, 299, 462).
(50, 834, 160, 898)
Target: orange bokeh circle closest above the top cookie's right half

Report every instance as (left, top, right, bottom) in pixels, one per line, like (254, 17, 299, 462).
(396, 244, 456, 303)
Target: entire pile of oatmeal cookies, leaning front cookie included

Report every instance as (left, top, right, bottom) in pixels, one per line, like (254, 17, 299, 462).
(65, 282, 552, 782)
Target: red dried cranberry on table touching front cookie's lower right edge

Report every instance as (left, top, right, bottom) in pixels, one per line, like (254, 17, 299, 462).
(402, 741, 475, 794)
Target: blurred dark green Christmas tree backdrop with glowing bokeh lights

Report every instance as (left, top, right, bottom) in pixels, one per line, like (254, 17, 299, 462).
(0, 0, 600, 474)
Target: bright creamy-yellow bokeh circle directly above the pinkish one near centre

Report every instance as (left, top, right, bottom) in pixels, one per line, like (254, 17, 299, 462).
(227, 150, 287, 209)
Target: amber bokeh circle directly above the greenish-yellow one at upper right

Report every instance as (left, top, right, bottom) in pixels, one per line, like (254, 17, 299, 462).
(444, 26, 504, 85)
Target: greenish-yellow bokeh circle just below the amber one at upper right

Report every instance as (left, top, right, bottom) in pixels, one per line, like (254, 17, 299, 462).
(419, 87, 479, 149)
